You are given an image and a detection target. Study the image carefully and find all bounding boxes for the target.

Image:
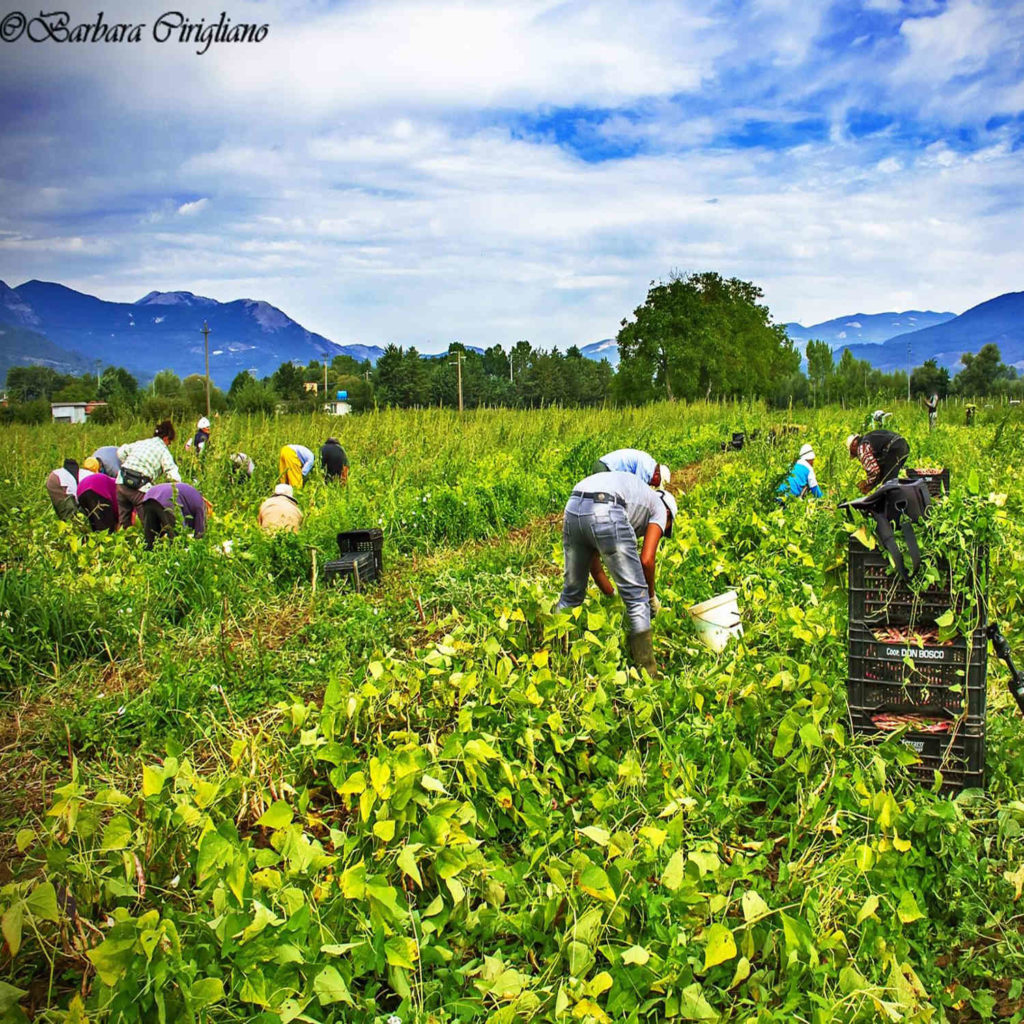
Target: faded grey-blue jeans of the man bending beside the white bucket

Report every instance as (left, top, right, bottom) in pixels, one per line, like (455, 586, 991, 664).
(557, 496, 650, 634)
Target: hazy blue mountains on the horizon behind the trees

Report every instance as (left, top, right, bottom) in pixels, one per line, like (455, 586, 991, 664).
(0, 281, 1024, 388)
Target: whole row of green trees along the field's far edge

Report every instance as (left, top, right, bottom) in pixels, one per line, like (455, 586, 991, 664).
(0, 272, 1024, 422)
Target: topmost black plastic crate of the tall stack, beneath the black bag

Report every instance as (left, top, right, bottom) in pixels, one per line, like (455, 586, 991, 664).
(849, 535, 988, 627)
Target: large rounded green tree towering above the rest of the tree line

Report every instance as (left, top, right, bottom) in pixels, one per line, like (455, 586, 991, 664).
(617, 272, 800, 401)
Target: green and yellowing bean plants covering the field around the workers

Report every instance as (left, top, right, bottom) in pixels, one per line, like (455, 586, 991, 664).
(0, 404, 1024, 1024)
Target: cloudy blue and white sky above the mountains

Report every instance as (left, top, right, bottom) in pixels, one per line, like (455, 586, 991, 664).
(0, 0, 1024, 351)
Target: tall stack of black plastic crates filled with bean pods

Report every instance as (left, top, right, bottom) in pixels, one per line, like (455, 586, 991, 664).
(847, 503, 988, 791)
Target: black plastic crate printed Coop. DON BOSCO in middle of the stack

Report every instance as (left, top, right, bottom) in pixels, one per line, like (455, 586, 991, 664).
(847, 623, 988, 720)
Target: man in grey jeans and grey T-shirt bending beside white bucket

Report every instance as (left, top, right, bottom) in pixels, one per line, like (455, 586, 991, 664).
(557, 473, 677, 676)
